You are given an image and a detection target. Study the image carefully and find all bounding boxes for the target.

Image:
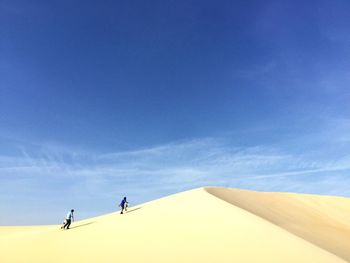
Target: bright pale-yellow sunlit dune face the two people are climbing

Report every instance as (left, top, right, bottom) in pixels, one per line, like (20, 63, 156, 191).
(0, 188, 347, 263)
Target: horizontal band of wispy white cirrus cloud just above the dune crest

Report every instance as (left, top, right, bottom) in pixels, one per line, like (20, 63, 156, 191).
(0, 136, 350, 188)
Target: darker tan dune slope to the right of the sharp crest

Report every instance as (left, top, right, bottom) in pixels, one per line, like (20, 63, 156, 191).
(206, 187, 350, 262)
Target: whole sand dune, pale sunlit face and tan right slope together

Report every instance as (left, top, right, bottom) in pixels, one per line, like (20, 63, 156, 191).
(0, 188, 350, 263)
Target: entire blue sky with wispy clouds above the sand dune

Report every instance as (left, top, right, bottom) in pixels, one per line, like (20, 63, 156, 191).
(0, 0, 350, 224)
